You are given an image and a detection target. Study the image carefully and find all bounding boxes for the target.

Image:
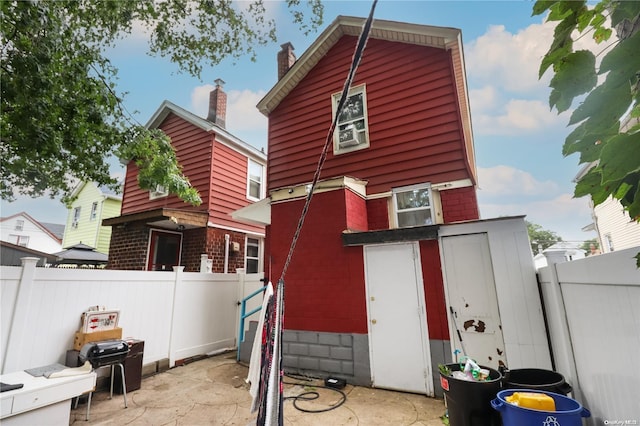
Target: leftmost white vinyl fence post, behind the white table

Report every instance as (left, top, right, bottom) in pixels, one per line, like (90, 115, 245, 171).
(2, 257, 40, 374)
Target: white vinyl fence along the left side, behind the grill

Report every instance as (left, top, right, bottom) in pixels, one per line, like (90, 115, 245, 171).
(0, 258, 263, 374)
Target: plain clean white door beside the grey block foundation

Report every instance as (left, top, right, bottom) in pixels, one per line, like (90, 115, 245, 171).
(364, 243, 433, 396)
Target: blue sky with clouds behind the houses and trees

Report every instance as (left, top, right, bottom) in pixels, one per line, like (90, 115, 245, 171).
(1, 0, 597, 241)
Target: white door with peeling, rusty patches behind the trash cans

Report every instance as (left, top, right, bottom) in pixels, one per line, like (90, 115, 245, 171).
(442, 234, 506, 369)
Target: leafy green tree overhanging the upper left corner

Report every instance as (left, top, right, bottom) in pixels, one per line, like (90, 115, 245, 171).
(0, 0, 323, 205)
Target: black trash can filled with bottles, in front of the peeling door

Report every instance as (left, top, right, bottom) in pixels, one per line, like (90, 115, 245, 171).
(440, 364, 502, 426)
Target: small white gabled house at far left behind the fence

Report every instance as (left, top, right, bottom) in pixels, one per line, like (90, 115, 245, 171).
(0, 212, 64, 253)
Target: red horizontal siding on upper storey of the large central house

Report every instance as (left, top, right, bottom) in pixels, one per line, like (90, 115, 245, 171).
(268, 36, 470, 194)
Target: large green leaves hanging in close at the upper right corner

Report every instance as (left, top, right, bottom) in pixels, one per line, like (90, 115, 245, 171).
(533, 0, 640, 266)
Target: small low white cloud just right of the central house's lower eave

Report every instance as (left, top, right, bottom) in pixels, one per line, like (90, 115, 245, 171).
(478, 166, 558, 197)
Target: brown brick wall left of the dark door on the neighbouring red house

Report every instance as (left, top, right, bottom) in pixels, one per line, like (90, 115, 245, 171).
(107, 223, 149, 271)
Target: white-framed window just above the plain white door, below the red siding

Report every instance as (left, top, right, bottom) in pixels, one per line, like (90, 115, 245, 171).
(393, 183, 435, 228)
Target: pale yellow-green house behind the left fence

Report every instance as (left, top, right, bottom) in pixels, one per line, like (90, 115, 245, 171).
(62, 182, 122, 255)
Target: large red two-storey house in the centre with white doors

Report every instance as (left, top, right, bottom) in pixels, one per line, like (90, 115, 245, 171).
(234, 16, 550, 395)
